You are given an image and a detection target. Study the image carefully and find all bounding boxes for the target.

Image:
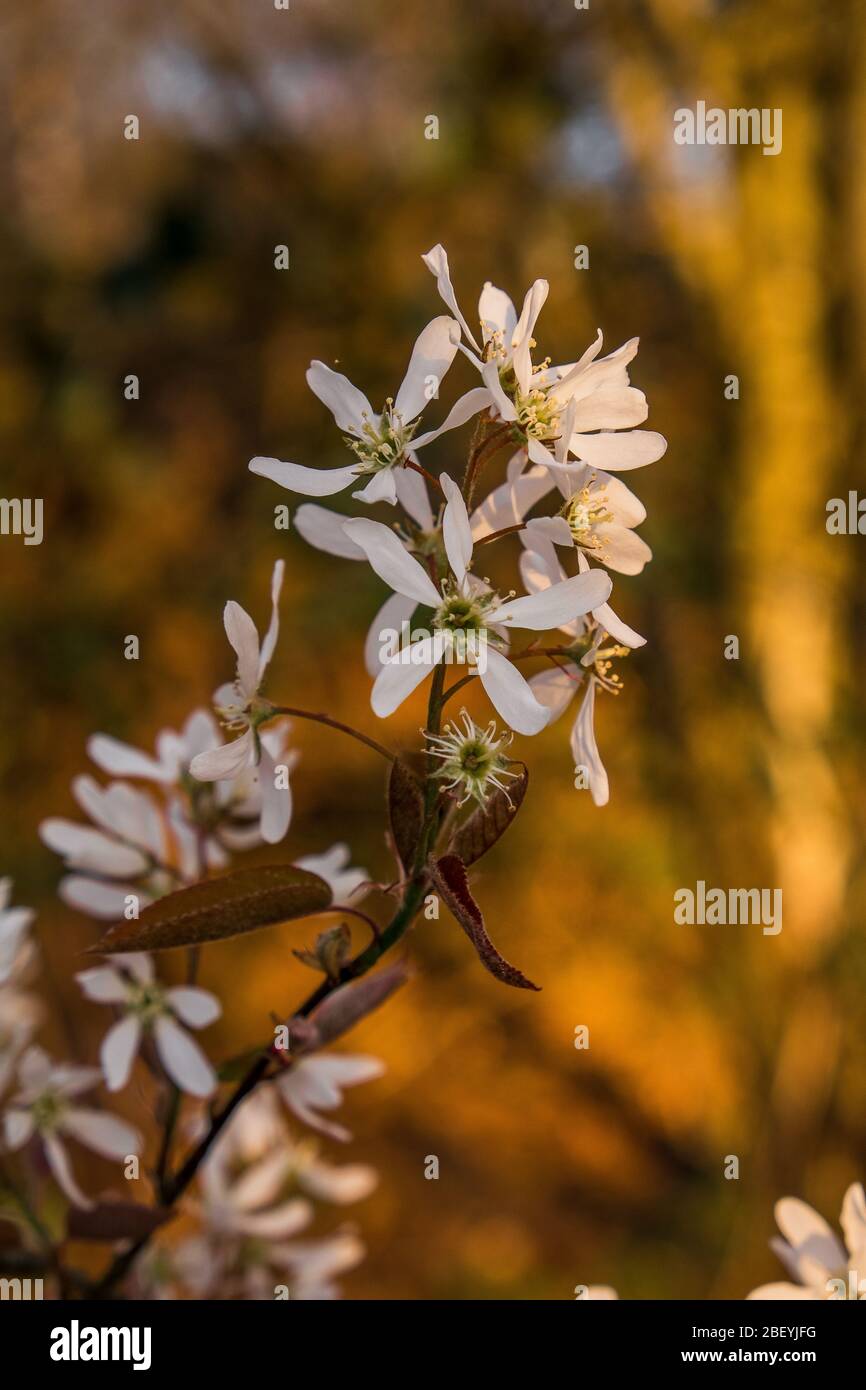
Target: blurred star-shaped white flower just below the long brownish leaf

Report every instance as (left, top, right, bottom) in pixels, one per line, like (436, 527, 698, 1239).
(75, 954, 222, 1097)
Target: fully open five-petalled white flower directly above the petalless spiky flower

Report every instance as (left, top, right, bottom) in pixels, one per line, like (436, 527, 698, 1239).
(343, 473, 610, 734)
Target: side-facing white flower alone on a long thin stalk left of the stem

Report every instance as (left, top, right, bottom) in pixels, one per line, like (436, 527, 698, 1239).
(189, 560, 292, 845)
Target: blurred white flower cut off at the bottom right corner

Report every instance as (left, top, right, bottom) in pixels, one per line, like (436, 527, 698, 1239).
(748, 1183, 866, 1302)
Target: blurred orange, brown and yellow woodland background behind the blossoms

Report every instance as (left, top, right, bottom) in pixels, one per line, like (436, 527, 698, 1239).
(0, 0, 866, 1300)
